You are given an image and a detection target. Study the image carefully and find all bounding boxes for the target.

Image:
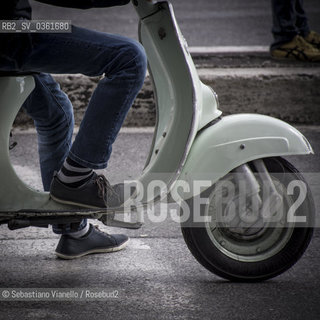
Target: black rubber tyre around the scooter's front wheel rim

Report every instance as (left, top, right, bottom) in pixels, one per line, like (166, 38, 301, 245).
(181, 157, 315, 282)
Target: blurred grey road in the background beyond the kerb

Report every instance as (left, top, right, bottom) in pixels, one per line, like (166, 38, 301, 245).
(30, 0, 320, 46)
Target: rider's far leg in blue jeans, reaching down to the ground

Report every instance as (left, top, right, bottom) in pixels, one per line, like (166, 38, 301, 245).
(23, 73, 87, 235)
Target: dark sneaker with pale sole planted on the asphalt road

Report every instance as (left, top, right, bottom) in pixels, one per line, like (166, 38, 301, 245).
(55, 224, 129, 259)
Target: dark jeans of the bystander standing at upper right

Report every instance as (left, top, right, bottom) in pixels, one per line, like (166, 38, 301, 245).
(271, 0, 310, 49)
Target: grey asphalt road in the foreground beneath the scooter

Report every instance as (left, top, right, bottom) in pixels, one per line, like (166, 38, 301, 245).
(0, 127, 320, 320)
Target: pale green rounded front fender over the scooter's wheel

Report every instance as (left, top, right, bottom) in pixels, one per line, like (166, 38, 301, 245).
(173, 114, 313, 199)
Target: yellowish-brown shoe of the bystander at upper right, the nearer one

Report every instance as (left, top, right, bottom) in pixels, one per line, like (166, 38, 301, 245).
(270, 35, 320, 62)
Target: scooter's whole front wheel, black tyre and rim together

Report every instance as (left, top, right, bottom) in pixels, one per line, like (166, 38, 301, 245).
(181, 157, 315, 282)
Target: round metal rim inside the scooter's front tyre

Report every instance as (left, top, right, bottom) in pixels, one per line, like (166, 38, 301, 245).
(205, 177, 294, 262)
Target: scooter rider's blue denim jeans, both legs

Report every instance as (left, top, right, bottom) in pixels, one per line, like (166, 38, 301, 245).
(0, 26, 147, 233)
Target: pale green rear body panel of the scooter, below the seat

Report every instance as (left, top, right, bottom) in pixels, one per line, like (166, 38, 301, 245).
(0, 76, 79, 212)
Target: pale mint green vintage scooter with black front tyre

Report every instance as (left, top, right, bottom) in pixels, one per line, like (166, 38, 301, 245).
(0, 0, 314, 281)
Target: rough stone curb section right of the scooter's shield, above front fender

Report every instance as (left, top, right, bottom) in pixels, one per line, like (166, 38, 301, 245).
(198, 68, 320, 125)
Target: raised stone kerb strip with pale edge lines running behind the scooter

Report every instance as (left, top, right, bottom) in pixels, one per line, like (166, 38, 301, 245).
(16, 46, 320, 127)
